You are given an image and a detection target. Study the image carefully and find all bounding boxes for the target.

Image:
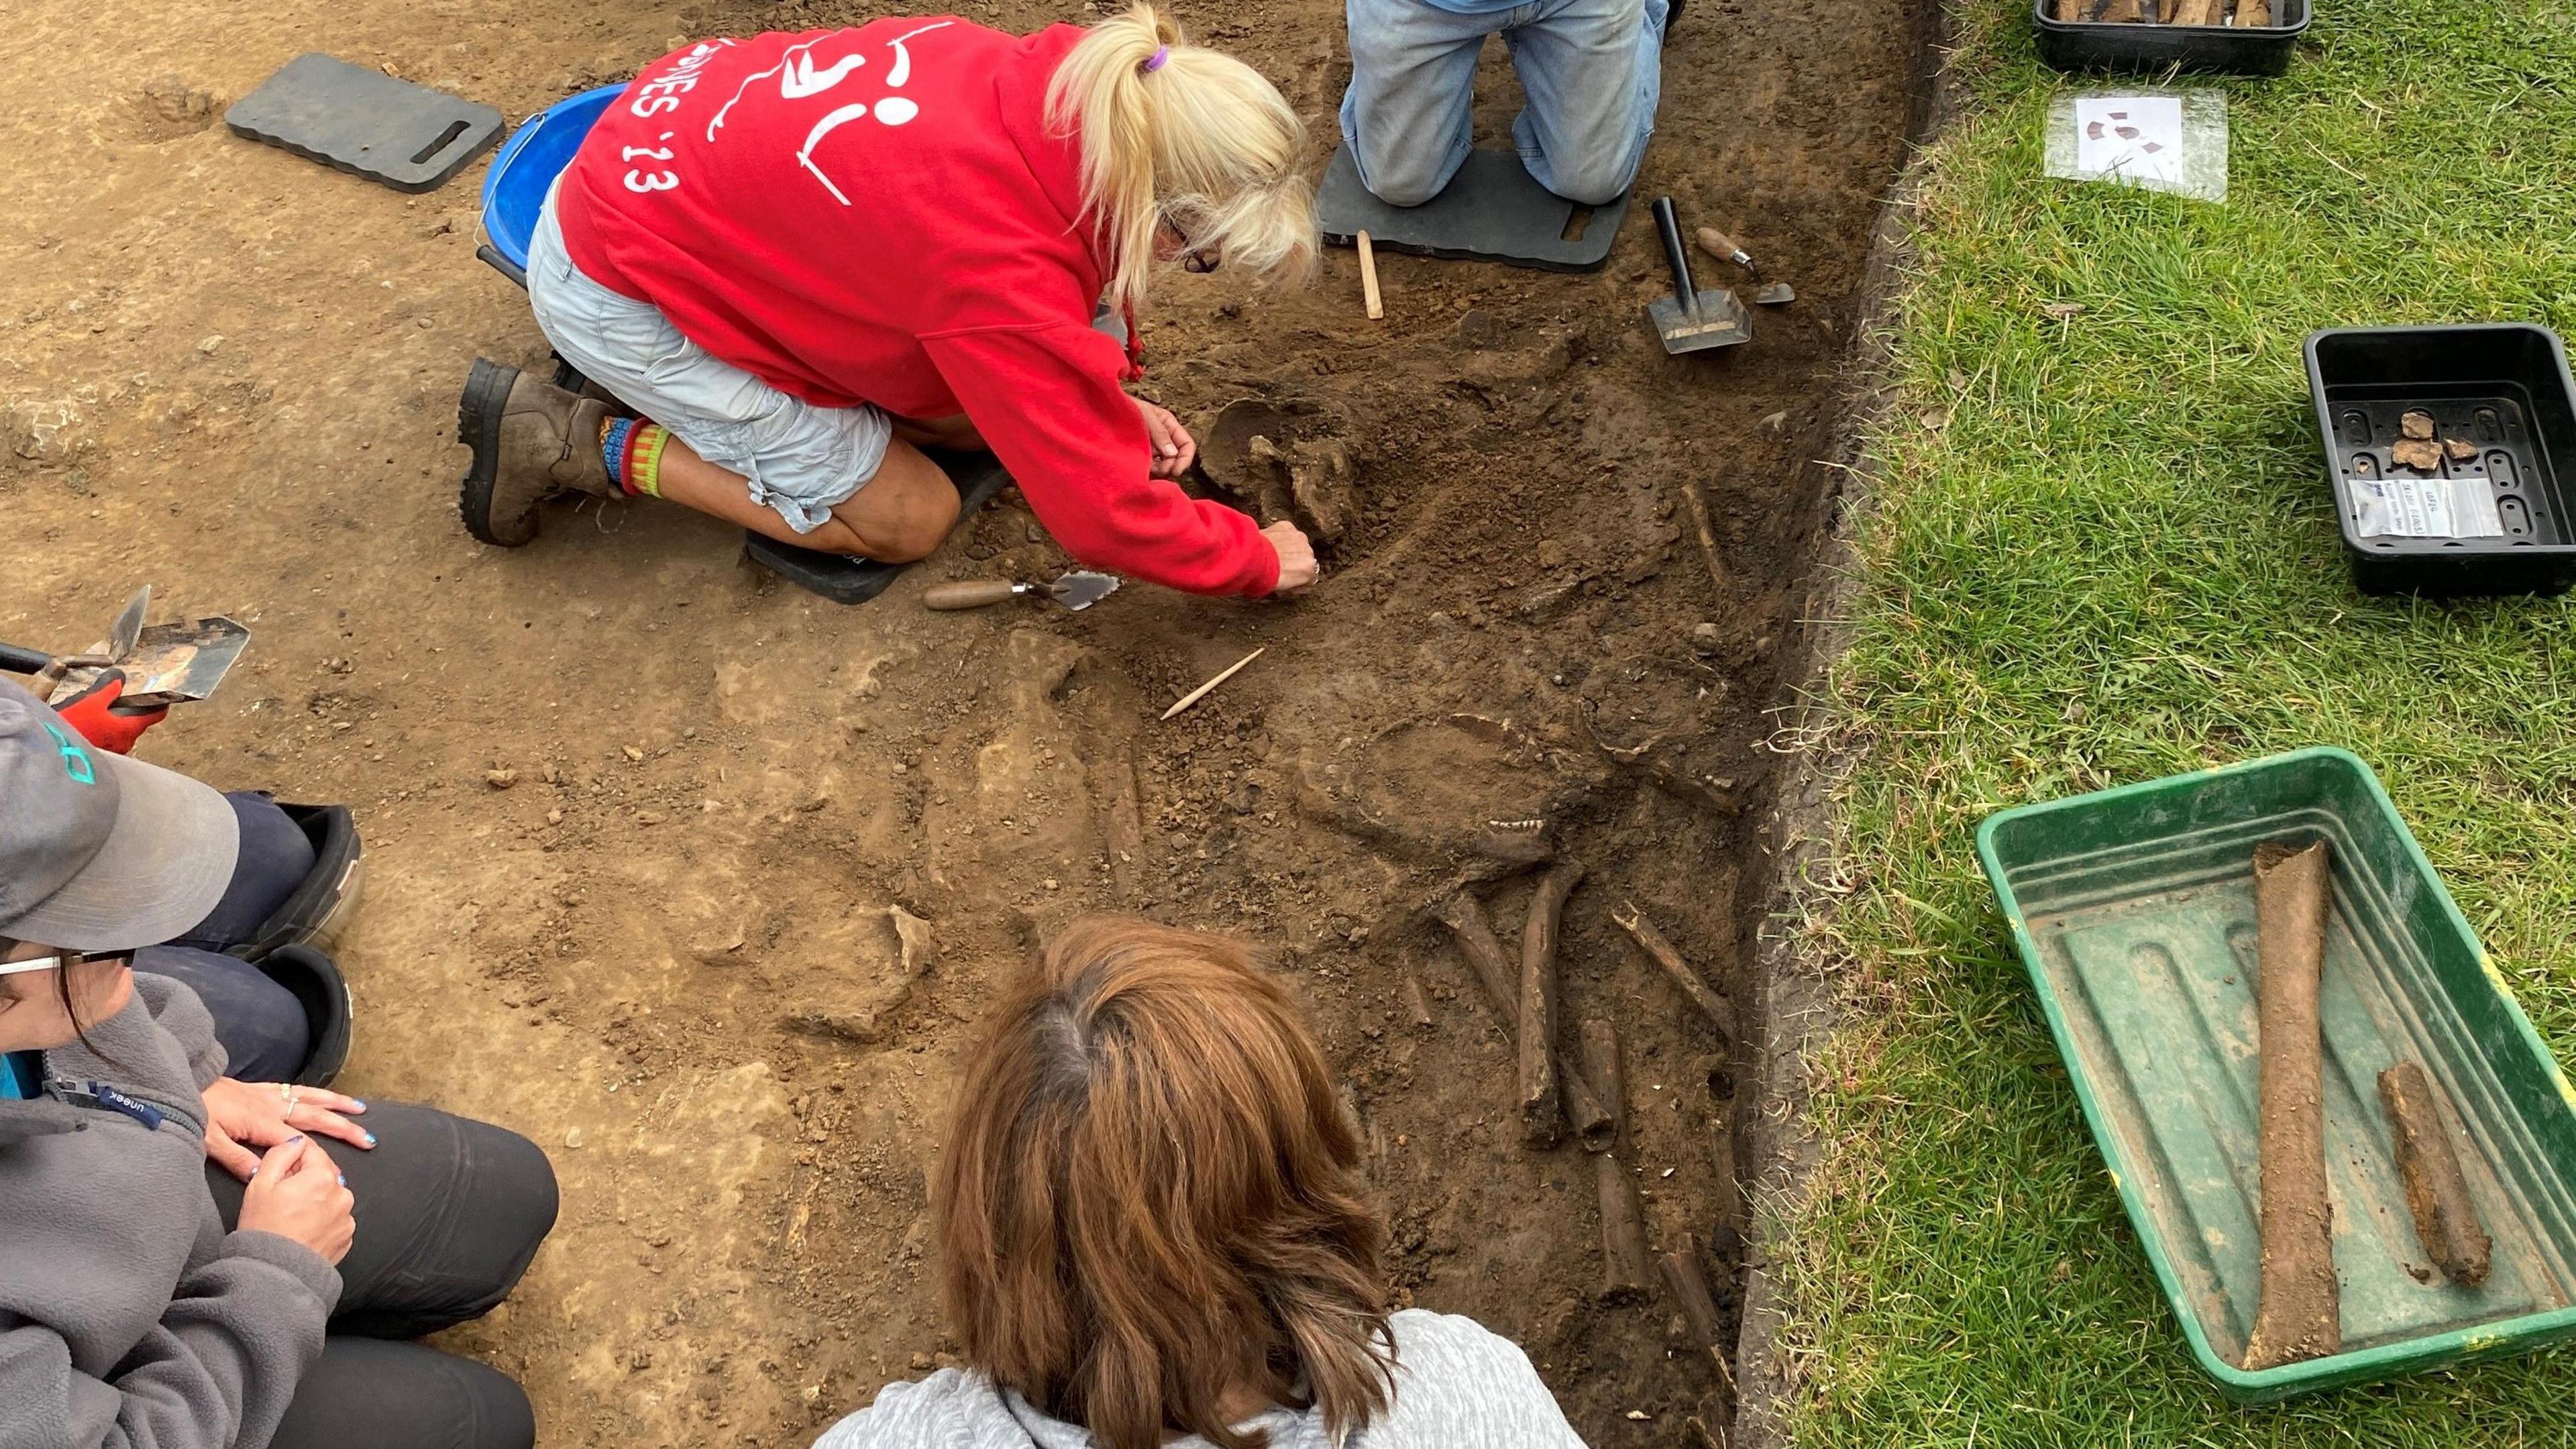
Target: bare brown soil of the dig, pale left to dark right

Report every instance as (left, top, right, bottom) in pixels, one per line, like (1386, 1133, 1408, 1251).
(0, 0, 1919, 1446)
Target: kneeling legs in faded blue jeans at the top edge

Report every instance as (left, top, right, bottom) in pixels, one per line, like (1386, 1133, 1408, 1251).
(1342, 0, 1680, 206)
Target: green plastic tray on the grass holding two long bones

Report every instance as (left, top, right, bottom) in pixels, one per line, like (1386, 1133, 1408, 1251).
(1976, 748, 2576, 1403)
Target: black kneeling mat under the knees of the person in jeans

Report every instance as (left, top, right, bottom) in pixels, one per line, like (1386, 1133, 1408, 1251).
(1313, 147, 1628, 271)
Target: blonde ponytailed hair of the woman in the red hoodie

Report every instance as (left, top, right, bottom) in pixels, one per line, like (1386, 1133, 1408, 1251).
(1046, 5, 1316, 307)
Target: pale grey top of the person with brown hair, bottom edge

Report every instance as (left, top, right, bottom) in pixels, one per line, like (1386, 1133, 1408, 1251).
(814, 1307, 1585, 1449)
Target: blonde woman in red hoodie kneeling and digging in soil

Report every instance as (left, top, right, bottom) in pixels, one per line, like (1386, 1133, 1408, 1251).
(459, 5, 1316, 596)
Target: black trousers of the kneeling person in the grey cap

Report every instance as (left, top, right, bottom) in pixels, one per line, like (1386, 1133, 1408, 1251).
(206, 1104, 556, 1449)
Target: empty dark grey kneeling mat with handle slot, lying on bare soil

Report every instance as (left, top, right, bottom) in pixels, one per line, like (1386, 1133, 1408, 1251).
(224, 52, 500, 191)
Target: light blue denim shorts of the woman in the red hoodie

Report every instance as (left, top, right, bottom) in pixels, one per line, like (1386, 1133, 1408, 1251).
(528, 191, 894, 534)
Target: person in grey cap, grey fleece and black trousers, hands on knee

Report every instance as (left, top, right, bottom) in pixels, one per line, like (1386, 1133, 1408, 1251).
(0, 684, 556, 1449)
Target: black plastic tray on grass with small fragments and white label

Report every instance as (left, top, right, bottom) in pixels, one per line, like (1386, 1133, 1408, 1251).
(2306, 322, 2576, 596)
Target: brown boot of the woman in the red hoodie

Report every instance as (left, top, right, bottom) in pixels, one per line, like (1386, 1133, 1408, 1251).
(456, 358, 621, 549)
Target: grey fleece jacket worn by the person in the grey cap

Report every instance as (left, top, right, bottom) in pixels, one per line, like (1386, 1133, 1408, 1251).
(0, 975, 340, 1449)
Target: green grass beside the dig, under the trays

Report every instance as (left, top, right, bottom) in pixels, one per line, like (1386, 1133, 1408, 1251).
(1785, 0, 2576, 1449)
